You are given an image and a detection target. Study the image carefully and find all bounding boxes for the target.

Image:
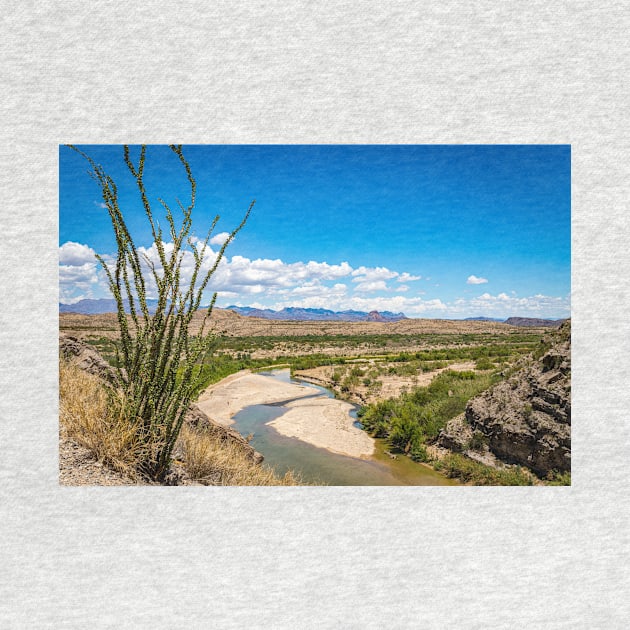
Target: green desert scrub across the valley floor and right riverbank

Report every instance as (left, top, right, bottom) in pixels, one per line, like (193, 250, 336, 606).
(81, 314, 570, 485)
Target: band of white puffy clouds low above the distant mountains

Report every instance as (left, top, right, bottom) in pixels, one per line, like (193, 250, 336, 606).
(59, 241, 570, 319)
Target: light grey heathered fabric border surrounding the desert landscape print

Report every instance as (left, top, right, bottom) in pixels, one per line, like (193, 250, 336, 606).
(0, 0, 630, 629)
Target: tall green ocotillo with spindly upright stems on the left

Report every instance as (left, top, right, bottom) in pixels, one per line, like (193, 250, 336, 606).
(72, 145, 255, 481)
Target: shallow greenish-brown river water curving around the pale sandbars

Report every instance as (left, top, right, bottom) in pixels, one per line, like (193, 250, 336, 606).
(232, 369, 456, 486)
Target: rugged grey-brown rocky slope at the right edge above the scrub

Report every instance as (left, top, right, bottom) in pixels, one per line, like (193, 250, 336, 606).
(438, 321, 571, 477)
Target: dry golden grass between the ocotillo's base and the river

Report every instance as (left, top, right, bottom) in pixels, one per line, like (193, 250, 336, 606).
(179, 426, 303, 486)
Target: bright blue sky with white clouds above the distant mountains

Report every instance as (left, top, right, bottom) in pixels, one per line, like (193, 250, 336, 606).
(59, 145, 571, 318)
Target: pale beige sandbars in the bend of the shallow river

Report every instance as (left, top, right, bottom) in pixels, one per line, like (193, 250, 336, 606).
(197, 371, 374, 457)
